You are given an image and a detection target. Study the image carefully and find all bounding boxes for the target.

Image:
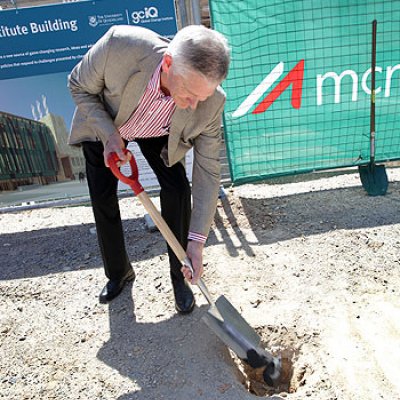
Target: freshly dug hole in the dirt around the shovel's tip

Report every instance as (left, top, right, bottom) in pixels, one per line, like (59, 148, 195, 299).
(230, 326, 311, 397)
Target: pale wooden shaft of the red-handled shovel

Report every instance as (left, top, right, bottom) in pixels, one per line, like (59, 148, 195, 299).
(137, 191, 214, 305)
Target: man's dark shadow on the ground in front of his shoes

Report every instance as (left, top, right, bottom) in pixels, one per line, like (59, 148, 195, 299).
(97, 290, 241, 400)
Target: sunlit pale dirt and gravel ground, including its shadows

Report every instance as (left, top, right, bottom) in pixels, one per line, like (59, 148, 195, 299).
(0, 168, 400, 400)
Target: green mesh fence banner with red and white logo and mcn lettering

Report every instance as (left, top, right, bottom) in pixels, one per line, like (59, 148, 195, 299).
(210, 0, 400, 183)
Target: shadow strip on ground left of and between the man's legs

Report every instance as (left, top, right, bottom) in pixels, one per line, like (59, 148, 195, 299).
(0, 218, 166, 280)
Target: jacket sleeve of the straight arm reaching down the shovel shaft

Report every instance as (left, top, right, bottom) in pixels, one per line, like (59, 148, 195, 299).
(190, 100, 225, 237)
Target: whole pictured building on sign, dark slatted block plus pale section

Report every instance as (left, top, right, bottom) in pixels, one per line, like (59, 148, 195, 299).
(0, 107, 85, 190)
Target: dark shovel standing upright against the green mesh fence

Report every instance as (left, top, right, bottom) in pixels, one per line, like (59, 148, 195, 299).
(358, 20, 389, 196)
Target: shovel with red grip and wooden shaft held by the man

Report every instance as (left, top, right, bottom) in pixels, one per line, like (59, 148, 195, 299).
(108, 150, 281, 386)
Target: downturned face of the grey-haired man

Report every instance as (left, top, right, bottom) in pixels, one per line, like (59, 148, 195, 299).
(162, 55, 218, 110)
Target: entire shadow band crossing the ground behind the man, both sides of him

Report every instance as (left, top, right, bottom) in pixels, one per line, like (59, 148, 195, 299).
(0, 182, 400, 280)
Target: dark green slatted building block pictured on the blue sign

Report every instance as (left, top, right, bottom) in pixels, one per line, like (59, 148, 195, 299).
(0, 112, 59, 190)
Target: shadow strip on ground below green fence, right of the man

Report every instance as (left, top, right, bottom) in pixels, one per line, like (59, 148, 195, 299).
(208, 182, 400, 257)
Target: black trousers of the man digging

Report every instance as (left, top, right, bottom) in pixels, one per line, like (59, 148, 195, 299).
(82, 136, 191, 280)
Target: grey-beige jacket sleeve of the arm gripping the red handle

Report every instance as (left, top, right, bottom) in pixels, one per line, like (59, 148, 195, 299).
(68, 28, 116, 143)
